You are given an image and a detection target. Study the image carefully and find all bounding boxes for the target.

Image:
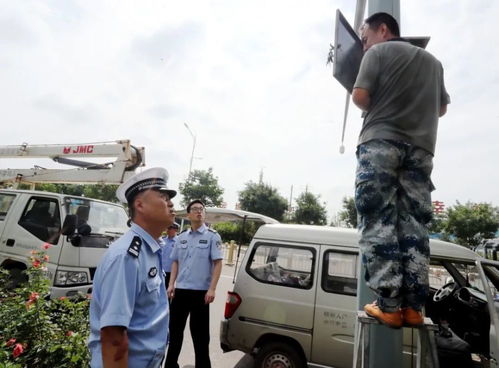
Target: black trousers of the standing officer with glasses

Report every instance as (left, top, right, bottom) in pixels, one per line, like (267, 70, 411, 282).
(165, 289, 211, 368)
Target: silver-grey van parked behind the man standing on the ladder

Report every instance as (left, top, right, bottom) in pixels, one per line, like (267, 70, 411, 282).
(220, 224, 499, 368)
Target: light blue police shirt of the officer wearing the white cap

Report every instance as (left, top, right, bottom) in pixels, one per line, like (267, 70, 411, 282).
(88, 224, 169, 368)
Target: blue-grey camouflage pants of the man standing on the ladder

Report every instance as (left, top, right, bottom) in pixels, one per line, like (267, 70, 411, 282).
(355, 139, 434, 312)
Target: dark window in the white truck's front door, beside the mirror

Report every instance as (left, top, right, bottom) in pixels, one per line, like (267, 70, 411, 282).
(19, 197, 61, 244)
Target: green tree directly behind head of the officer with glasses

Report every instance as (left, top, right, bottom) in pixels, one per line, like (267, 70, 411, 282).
(179, 167, 224, 207)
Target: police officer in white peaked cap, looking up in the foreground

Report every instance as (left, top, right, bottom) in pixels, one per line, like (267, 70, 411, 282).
(89, 168, 177, 368)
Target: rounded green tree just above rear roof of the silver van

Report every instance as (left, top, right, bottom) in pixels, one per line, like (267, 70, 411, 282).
(239, 181, 288, 221)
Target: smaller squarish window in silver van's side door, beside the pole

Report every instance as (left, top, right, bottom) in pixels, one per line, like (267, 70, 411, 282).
(322, 251, 358, 295)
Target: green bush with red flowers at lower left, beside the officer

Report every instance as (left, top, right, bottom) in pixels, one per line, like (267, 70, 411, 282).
(0, 243, 89, 368)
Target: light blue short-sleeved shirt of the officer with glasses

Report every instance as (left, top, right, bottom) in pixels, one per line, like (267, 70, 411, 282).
(171, 224, 223, 290)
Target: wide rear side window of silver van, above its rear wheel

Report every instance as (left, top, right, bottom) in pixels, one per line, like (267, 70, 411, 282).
(246, 244, 315, 289)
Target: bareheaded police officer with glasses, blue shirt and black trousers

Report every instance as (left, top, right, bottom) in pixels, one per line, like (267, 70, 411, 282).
(165, 199, 223, 368)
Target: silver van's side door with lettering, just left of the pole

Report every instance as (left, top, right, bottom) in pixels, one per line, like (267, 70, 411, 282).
(311, 246, 358, 368)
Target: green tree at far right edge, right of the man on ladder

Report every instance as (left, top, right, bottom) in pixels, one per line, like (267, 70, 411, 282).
(444, 201, 499, 247)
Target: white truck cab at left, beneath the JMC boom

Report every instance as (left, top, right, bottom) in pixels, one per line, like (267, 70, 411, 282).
(0, 189, 128, 298)
